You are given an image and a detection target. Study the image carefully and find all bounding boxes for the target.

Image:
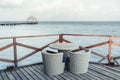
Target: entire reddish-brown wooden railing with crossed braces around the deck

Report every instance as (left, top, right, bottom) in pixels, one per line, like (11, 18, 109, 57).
(0, 34, 120, 67)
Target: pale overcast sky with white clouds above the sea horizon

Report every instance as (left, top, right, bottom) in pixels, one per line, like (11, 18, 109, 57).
(0, 0, 120, 21)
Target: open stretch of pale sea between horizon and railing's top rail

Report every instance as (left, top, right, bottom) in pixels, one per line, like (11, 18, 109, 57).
(0, 22, 120, 37)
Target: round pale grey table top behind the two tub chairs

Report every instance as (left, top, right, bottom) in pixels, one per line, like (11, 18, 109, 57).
(49, 43, 79, 50)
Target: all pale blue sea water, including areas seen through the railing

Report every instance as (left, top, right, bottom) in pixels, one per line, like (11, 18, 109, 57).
(0, 21, 120, 69)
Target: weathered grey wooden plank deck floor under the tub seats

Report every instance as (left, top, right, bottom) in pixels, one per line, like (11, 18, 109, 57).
(0, 64, 120, 80)
